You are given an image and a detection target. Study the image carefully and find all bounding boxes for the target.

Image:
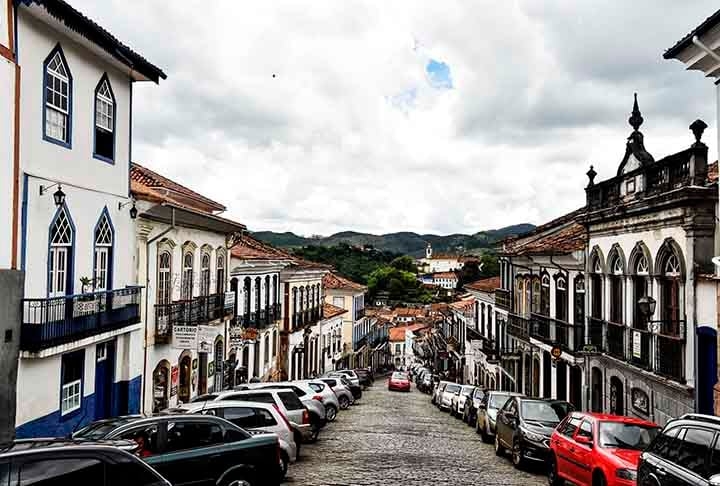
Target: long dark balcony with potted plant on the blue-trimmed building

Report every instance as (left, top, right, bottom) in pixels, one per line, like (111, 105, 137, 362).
(20, 287, 142, 352)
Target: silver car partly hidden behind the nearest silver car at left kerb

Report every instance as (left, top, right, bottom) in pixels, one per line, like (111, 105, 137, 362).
(190, 388, 326, 442)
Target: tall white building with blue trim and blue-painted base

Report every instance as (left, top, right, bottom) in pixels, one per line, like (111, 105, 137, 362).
(13, 0, 165, 437)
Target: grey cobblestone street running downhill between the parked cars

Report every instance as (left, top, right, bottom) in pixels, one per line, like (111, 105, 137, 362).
(285, 379, 547, 486)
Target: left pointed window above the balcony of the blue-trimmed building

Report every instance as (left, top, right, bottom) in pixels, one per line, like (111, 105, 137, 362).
(48, 204, 75, 297)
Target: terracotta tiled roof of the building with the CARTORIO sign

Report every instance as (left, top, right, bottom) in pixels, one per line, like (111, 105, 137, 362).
(130, 162, 226, 213)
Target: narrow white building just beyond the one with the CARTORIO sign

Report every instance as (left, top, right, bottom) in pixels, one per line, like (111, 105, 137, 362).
(230, 235, 293, 383)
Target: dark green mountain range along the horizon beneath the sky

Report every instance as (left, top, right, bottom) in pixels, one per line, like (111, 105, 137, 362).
(253, 223, 535, 256)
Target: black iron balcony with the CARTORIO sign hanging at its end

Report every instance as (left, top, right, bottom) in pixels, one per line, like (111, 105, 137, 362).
(155, 294, 234, 344)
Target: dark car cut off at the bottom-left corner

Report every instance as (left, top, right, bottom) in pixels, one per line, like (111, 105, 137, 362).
(0, 439, 171, 486)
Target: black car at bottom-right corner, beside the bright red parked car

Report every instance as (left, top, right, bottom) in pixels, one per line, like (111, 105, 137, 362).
(637, 414, 720, 486)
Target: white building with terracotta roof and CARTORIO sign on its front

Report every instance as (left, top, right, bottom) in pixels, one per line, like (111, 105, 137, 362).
(130, 163, 240, 412)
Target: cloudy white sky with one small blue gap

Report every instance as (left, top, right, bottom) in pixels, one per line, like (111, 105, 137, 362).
(72, 0, 717, 235)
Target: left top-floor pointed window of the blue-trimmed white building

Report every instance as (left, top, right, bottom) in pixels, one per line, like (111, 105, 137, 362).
(43, 44, 72, 147)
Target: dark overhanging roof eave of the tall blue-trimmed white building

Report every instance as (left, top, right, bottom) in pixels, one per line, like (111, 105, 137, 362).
(16, 0, 167, 83)
